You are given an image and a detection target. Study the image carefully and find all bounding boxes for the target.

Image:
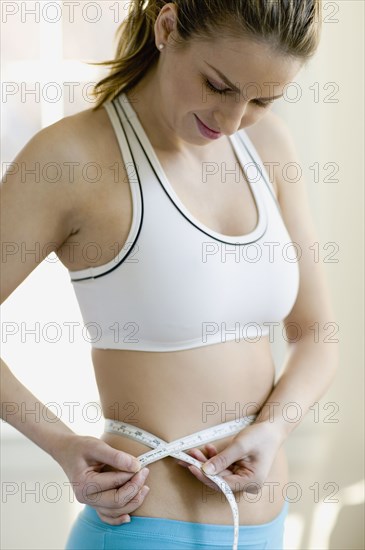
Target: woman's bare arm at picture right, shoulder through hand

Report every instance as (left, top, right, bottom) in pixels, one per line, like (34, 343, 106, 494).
(179, 113, 339, 493)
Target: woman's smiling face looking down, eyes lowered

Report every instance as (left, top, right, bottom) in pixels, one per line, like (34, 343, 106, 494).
(158, 33, 302, 145)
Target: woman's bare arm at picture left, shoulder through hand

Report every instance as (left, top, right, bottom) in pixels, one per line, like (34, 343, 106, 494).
(0, 117, 148, 525)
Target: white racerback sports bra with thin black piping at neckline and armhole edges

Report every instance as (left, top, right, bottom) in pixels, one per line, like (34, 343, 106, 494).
(69, 93, 299, 351)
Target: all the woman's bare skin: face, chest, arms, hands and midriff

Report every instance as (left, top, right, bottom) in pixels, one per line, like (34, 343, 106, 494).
(2, 4, 337, 525)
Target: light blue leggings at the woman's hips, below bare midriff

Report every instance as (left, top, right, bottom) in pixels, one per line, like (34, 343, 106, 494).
(65, 501, 289, 550)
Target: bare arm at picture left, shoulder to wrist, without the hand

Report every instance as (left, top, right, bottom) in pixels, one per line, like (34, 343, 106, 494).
(0, 121, 82, 459)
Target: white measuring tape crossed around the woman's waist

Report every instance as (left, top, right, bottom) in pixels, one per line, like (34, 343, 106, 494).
(105, 415, 257, 550)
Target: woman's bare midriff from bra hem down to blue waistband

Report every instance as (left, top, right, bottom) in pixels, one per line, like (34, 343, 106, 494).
(92, 336, 288, 525)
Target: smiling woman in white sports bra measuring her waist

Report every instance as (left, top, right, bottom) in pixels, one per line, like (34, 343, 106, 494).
(2, 0, 337, 549)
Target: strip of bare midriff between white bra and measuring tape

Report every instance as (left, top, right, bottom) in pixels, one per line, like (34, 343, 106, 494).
(92, 338, 275, 434)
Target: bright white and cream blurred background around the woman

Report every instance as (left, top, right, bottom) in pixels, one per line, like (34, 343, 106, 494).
(0, 0, 364, 550)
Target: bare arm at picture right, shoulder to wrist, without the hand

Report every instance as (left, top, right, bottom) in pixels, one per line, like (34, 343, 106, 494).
(250, 115, 339, 438)
